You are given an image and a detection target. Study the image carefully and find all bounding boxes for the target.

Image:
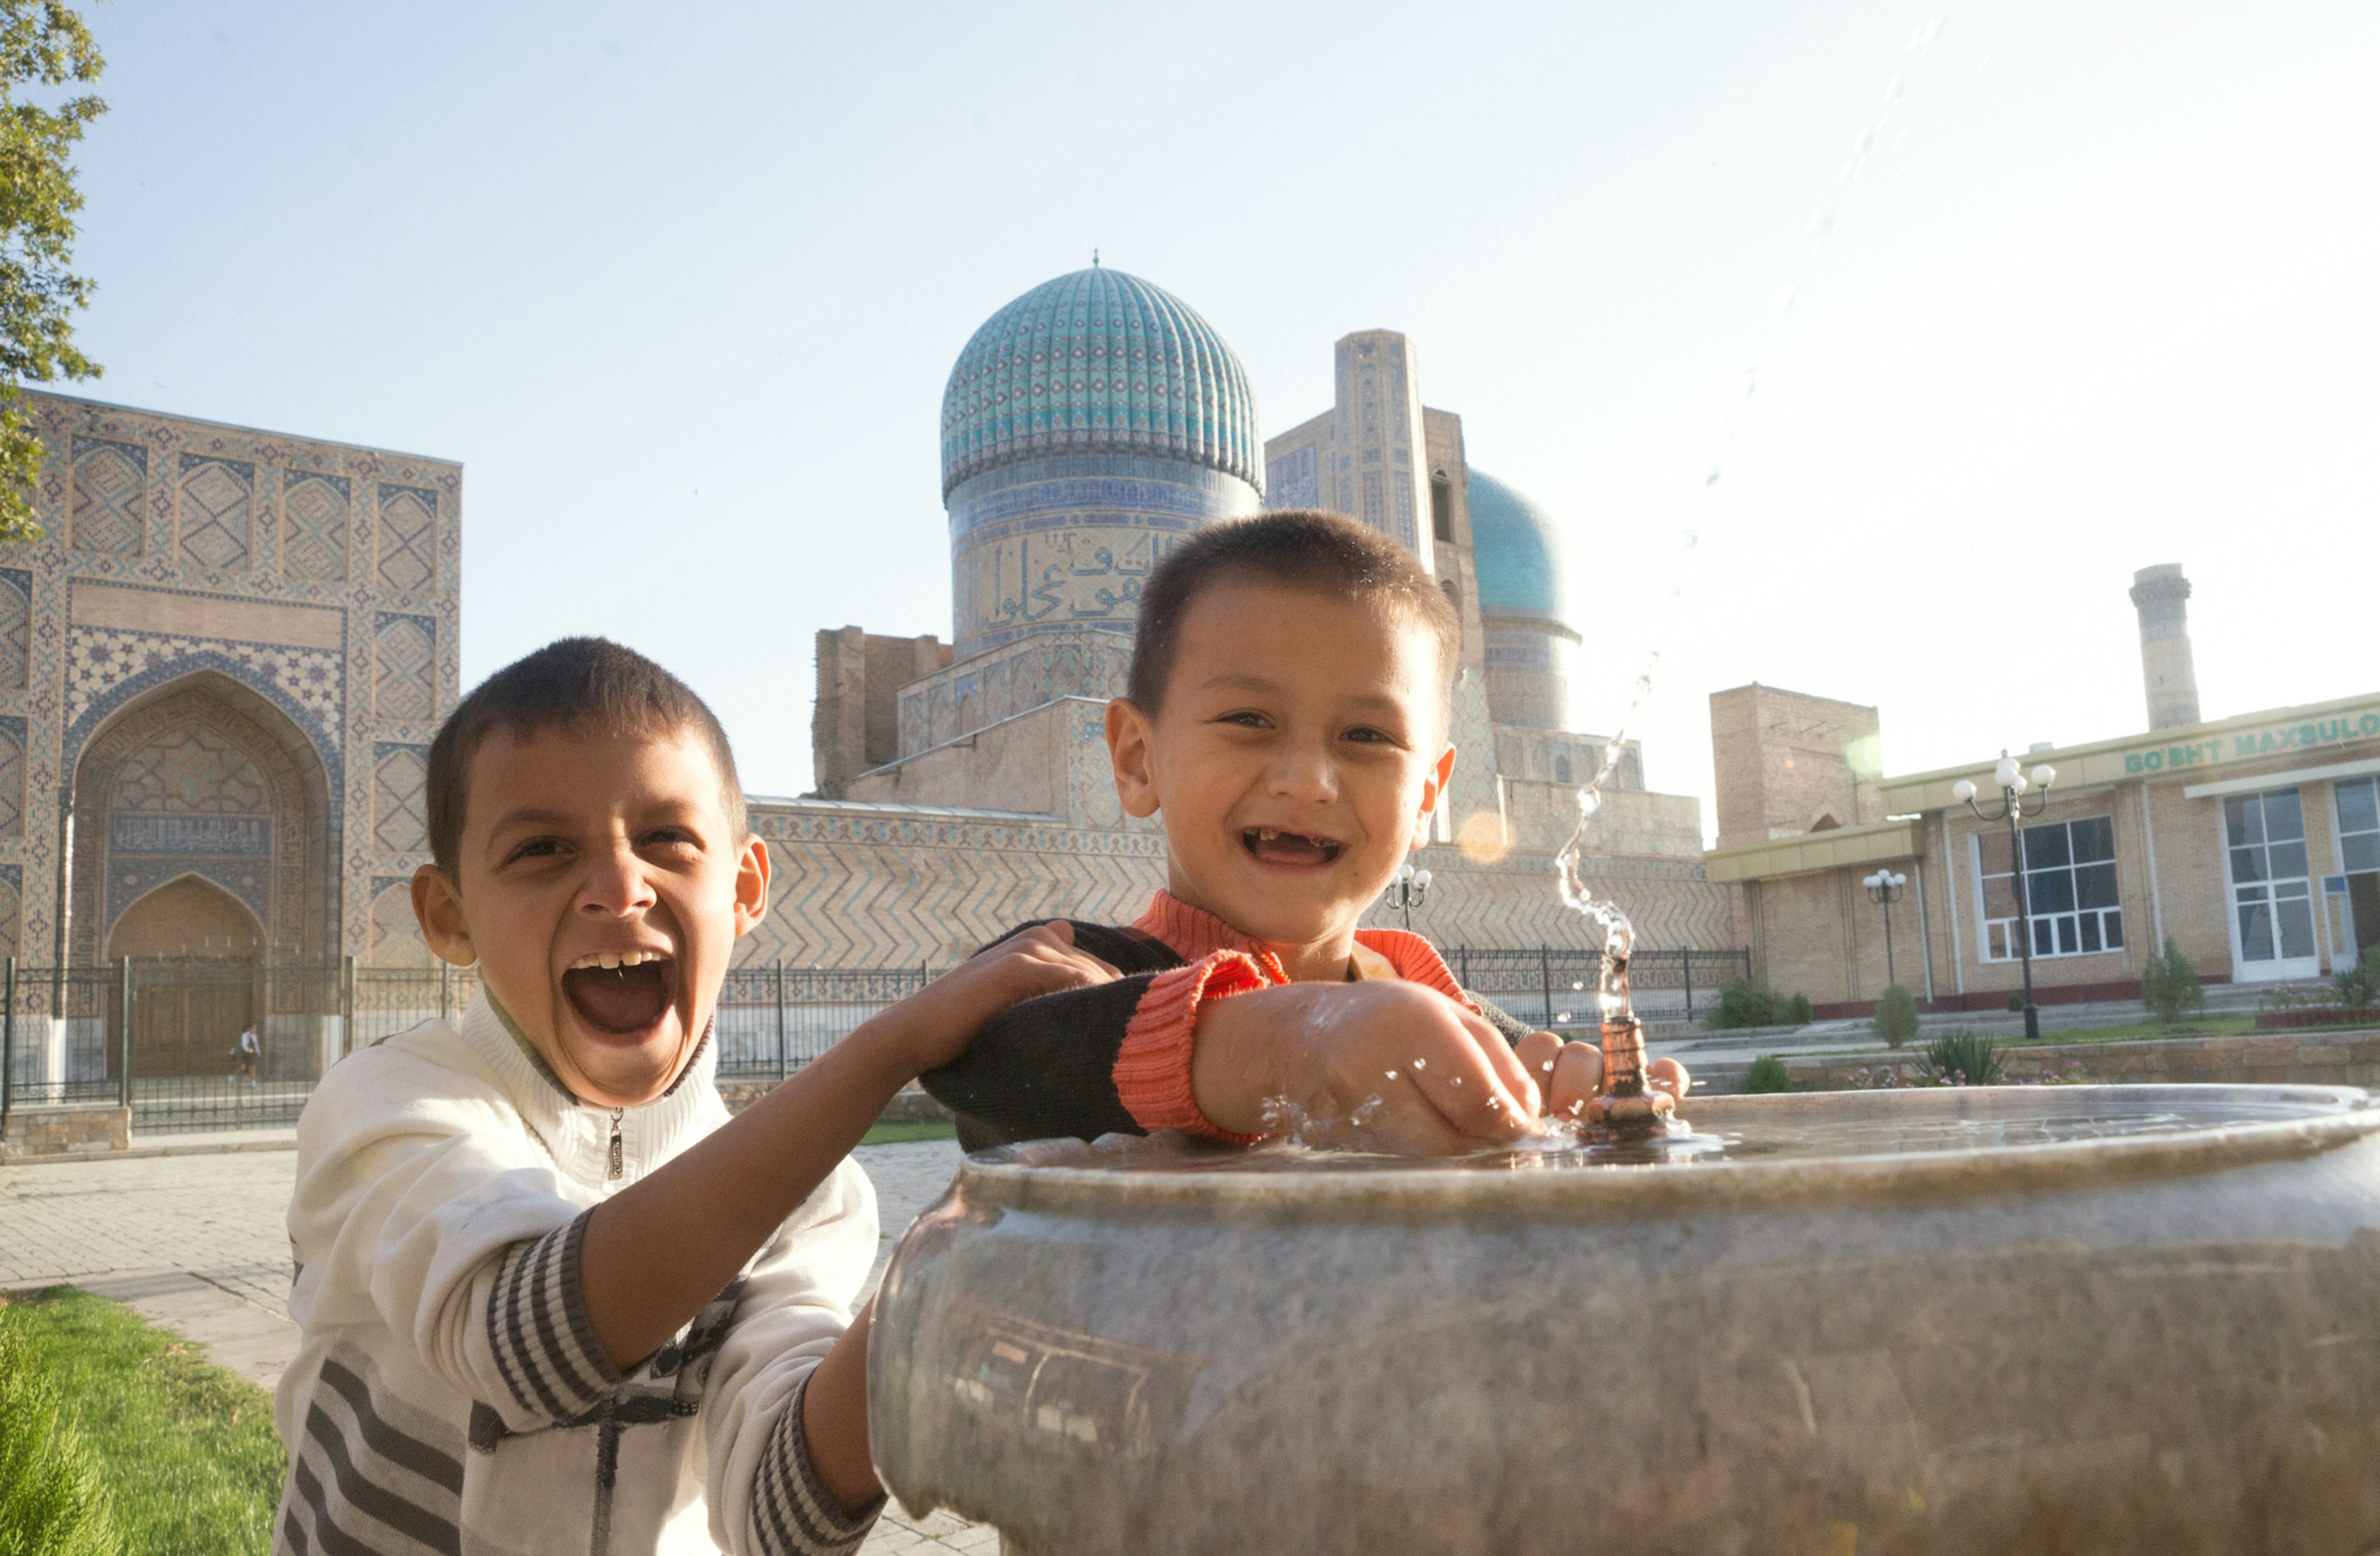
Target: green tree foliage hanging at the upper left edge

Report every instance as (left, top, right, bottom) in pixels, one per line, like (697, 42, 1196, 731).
(0, 0, 107, 542)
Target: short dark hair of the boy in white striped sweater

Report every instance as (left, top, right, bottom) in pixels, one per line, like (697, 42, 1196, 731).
(426, 638, 747, 880)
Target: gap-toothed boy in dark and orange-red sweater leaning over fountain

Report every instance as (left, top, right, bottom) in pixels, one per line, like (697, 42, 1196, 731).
(926, 511, 1688, 1152)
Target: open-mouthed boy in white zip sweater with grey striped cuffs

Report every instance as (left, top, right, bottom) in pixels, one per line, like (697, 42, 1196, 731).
(274, 638, 1111, 1556)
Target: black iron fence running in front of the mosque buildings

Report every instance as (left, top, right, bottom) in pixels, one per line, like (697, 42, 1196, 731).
(0, 947, 1752, 1135)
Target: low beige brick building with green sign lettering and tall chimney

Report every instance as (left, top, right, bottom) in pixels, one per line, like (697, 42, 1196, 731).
(1704, 566, 2380, 1014)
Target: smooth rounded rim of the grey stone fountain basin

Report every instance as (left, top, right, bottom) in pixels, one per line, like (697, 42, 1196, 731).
(957, 1085, 2380, 1221)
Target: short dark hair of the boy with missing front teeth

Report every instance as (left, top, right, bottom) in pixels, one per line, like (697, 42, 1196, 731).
(1123, 506, 1464, 716)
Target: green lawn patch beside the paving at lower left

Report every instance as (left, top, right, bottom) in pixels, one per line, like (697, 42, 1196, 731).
(0, 1287, 286, 1556)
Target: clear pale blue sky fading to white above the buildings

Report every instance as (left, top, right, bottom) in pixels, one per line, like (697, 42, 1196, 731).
(56, 0, 2380, 826)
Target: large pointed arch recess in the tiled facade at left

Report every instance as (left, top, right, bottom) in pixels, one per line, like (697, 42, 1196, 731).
(69, 671, 338, 966)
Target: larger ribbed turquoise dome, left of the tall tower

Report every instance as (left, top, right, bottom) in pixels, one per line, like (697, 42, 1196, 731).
(943, 267, 1264, 497)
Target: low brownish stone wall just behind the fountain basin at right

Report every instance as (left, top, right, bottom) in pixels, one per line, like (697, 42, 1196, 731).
(1685, 1028, 2380, 1097)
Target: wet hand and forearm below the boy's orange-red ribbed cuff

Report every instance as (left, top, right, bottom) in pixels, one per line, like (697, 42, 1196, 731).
(1190, 978, 1540, 1154)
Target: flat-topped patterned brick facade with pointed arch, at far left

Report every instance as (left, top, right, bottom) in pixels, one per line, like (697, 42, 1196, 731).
(0, 390, 462, 968)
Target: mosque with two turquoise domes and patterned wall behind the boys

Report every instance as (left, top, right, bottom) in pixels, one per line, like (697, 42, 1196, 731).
(790, 267, 1740, 966)
